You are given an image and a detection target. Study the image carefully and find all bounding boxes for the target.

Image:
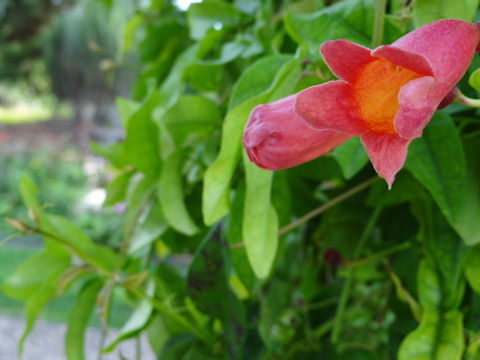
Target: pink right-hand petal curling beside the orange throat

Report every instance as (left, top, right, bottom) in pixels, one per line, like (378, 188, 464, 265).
(393, 76, 436, 139)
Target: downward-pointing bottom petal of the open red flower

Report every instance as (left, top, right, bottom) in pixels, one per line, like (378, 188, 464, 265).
(360, 132, 411, 189)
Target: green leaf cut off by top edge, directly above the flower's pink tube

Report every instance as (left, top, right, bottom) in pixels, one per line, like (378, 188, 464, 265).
(413, 0, 479, 27)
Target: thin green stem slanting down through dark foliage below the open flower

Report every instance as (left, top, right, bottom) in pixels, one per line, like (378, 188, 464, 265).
(331, 206, 382, 344)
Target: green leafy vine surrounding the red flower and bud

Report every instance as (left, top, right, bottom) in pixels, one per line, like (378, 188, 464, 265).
(4, 0, 480, 360)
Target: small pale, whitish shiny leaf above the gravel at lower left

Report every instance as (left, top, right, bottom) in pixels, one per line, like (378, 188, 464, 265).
(103, 282, 155, 353)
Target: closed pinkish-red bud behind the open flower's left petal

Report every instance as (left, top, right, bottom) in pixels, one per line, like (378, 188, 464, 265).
(242, 95, 350, 170)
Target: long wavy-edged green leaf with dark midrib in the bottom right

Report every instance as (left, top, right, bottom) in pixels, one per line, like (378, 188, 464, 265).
(398, 199, 465, 360)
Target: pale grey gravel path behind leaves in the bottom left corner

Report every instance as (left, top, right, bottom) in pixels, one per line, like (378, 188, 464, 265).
(0, 315, 155, 360)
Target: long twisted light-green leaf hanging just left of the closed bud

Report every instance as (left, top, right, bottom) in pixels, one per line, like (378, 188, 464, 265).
(202, 54, 300, 225)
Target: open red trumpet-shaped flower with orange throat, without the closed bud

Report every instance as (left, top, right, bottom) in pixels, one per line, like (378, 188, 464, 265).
(295, 19, 479, 188)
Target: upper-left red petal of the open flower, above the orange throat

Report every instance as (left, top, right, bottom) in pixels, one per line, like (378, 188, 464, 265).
(320, 39, 373, 82)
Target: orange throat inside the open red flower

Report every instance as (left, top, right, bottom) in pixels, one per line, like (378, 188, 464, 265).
(352, 59, 421, 134)
